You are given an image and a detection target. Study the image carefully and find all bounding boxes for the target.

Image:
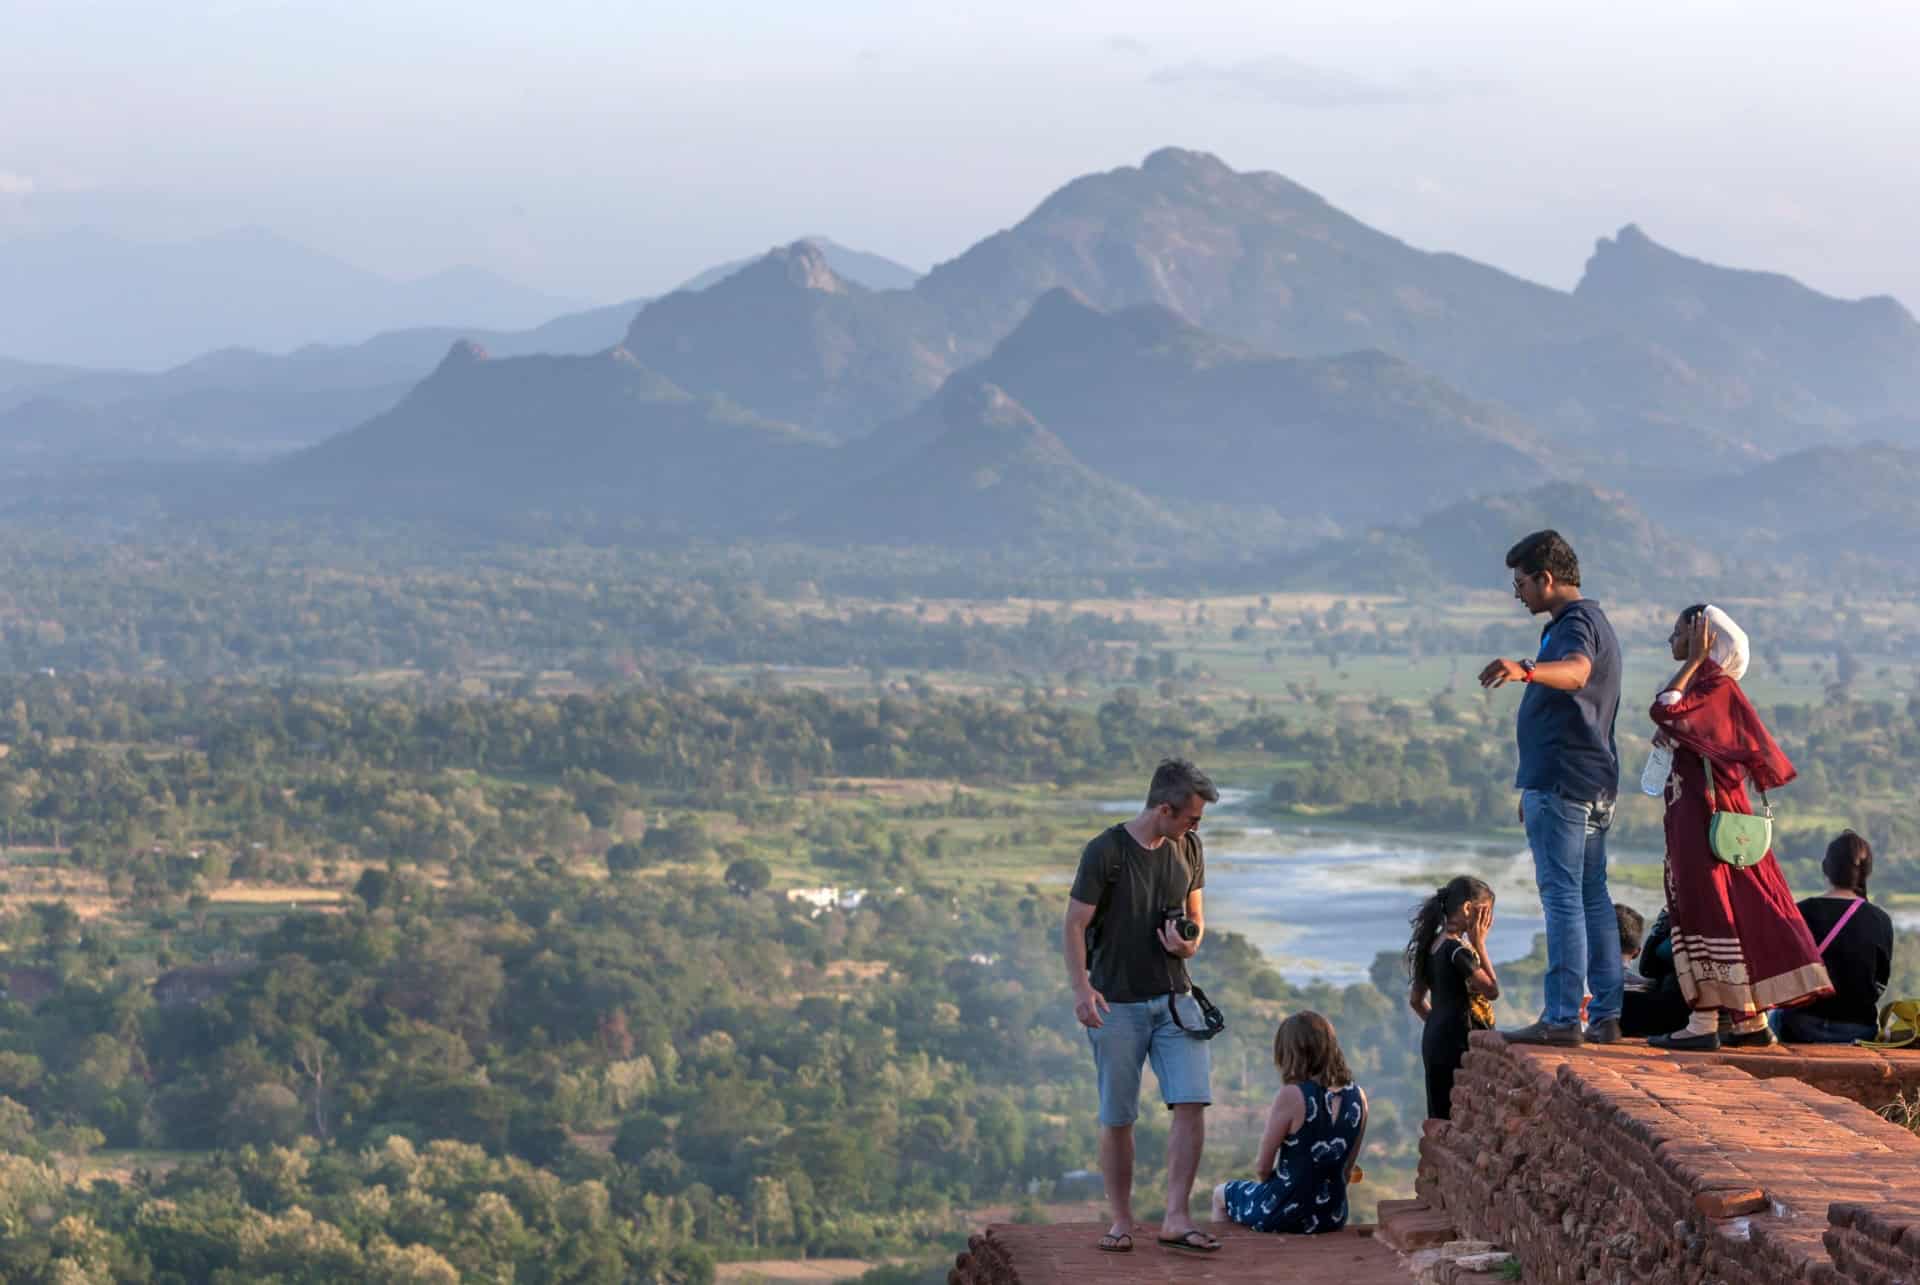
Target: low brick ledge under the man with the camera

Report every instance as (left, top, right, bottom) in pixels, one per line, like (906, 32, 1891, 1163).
(947, 1222, 1413, 1285)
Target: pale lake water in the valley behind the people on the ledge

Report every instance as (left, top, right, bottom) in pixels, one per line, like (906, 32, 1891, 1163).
(1102, 789, 1661, 983)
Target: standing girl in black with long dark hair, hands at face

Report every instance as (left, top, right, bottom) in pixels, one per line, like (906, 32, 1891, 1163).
(1407, 874, 1500, 1120)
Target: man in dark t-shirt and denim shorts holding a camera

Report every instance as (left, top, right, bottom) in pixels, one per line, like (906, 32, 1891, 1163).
(1062, 759, 1219, 1252)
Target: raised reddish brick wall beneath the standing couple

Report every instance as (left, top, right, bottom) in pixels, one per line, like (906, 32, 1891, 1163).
(1419, 1033, 1920, 1283)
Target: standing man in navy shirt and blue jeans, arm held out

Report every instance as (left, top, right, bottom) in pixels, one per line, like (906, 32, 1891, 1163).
(1480, 530, 1620, 1045)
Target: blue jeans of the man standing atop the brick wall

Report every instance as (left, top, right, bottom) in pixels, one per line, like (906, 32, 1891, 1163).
(1521, 789, 1620, 1026)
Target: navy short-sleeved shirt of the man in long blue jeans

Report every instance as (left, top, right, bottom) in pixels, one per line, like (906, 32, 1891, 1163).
(1515, 597, 1620, 799)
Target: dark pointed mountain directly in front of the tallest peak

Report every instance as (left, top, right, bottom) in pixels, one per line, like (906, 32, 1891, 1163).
(876, 288, 1553, 522)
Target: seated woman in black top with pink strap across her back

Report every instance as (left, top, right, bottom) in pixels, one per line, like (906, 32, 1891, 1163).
(1780, 830, 1893, 1045)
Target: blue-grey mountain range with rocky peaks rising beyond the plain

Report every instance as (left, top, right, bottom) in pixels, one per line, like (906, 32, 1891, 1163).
(0, 148, 1920, 582)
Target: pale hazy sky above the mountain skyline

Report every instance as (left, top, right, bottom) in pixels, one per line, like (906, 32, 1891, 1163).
(0, 0, 1920, 305)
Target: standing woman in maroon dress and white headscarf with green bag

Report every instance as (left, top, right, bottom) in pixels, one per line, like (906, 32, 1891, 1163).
(1647, 605, 1834, 1049)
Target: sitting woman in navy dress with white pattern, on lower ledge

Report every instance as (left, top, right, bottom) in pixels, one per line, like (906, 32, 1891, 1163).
(1213, 1012, 1367, 1235)
